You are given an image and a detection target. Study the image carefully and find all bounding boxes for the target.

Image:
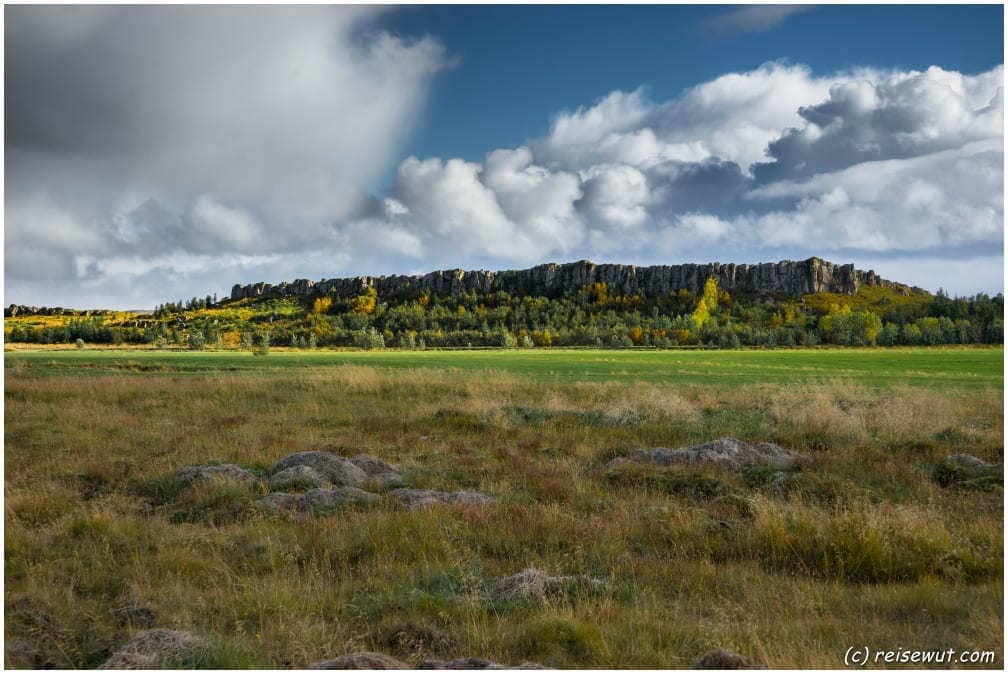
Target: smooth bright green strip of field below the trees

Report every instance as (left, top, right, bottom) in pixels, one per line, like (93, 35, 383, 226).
(5, 347, 1004, 388)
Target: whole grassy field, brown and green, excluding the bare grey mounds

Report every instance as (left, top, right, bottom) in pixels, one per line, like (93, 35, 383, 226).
(4, 349, 1004, 668)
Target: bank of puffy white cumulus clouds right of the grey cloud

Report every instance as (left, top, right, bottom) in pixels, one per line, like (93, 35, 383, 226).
(362, 63, 1003, 292)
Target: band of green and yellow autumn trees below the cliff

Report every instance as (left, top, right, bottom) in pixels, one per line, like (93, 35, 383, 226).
(7, 278, 1004, 349)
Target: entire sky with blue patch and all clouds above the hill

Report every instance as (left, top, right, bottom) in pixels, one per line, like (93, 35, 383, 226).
(4, 5, 1004, 308)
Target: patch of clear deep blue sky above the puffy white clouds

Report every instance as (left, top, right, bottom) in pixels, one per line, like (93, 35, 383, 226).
(377, 5, 1004, 176)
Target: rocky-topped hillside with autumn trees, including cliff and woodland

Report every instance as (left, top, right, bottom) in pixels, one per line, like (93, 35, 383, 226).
(4, 258, 1003, 353)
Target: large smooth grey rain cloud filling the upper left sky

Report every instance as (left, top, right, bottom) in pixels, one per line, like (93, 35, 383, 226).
(5, 6, 448, 298)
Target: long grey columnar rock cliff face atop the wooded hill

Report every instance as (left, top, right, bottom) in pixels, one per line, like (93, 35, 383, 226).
(231, 258, 910, 299)
